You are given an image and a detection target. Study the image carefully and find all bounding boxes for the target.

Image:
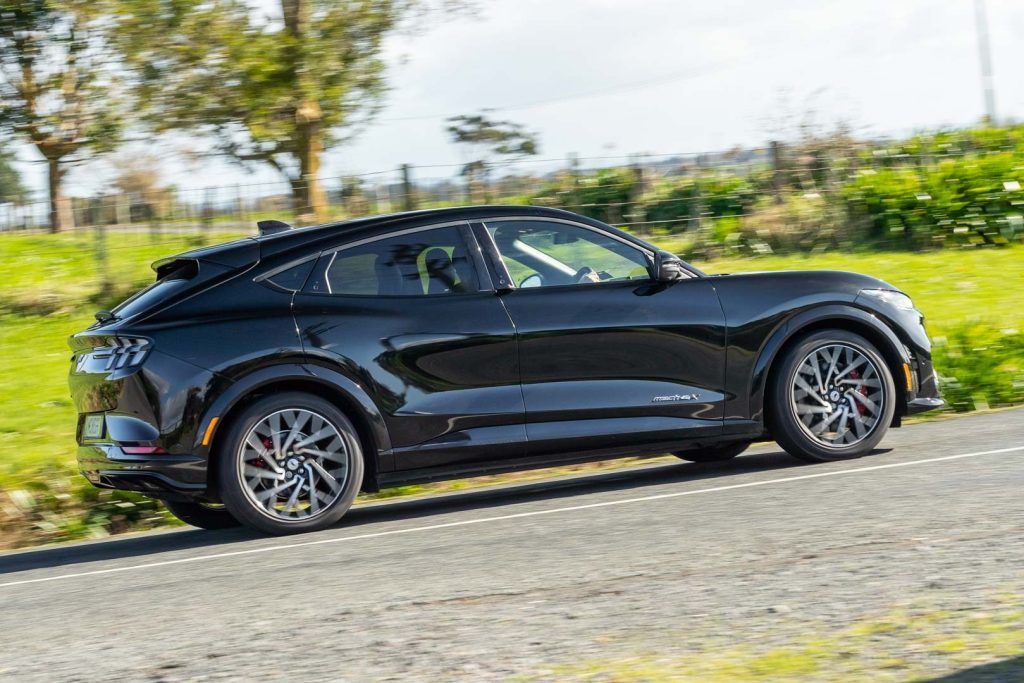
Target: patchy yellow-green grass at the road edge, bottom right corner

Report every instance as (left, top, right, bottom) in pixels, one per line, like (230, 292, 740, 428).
(536, 592, 1024, 683)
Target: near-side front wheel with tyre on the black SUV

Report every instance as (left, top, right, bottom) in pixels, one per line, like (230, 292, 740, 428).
(766, 330, 896, 462)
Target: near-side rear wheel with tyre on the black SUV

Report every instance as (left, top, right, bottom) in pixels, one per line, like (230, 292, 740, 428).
(218, 392, 364, 535)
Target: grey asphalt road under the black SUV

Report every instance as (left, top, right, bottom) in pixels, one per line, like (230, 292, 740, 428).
(0, 411, 1024, 681)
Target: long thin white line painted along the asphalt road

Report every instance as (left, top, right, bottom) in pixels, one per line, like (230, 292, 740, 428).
(0, 445, 1024, 588)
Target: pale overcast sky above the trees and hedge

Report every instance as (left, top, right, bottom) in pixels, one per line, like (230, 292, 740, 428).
(9, 0, 1024, 193)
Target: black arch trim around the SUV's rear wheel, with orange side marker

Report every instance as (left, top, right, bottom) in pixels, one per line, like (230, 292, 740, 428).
(194, 366, 391, 492)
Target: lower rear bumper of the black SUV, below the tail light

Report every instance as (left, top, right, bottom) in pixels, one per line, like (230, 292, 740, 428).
(78, 443, 207, 498)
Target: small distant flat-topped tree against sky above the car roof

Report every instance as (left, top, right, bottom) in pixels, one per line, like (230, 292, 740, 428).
(445, 114, 540, 194)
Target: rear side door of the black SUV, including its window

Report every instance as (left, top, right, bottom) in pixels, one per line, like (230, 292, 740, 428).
(294, 223, 525, 470)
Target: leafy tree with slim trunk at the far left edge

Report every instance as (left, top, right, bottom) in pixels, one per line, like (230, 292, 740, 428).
(0, 0, 121, 232)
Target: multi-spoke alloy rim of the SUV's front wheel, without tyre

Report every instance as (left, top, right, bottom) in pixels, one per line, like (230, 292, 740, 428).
(791, 343, 886, 449)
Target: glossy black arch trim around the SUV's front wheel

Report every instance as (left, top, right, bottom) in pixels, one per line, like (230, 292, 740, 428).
(749, 305, 910, 430)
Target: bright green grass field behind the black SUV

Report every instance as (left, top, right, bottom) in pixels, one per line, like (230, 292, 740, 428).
(0, 232, 1024, 547)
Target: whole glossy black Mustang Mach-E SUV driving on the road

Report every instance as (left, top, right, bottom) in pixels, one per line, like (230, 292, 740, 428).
(71, 206, 942, 533)
